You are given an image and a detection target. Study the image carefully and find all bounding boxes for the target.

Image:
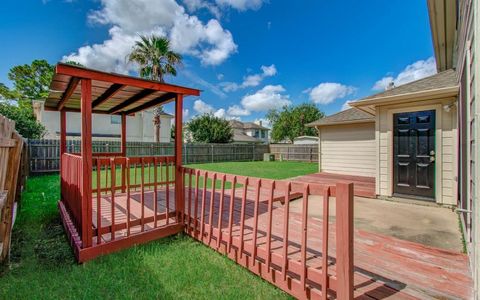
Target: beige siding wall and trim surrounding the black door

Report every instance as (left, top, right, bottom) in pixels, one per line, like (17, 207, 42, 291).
(375, 99, 457, 205)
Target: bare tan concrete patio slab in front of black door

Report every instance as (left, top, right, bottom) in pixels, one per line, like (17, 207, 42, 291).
(291, 197, 463, 253)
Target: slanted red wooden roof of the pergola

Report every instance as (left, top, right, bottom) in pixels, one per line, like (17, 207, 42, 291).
(45, 63, 200, 114)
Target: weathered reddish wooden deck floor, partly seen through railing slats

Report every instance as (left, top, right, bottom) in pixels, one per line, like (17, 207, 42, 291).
(92, 188, 472, 299)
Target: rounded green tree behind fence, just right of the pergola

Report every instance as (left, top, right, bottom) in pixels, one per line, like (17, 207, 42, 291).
(185, 114, 233, 143)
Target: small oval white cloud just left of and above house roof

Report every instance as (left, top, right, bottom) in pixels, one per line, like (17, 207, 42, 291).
(304, 82, 355, 104)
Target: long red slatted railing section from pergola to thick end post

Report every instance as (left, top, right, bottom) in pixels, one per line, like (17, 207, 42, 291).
(183, 168, 353, 299)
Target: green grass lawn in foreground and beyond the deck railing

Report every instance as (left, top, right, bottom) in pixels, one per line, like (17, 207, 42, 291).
(0, 162, 317, 299)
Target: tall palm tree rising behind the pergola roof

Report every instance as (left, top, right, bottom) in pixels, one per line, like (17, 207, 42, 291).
(127, 35, 182, 142)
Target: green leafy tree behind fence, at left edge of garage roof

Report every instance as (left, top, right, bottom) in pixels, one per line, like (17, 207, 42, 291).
(267, 103, 324, 143)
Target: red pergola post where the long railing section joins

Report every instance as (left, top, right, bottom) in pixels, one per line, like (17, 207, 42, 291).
(175, 94, 185, 222)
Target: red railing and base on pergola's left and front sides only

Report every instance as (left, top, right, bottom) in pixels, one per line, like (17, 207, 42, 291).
(59, 153, 183, 262)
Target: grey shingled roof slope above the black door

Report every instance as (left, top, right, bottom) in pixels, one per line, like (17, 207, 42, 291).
(359, 69, 458, 101)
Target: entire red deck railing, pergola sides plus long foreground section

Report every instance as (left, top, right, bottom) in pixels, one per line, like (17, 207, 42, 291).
(59, 154, 353, 299)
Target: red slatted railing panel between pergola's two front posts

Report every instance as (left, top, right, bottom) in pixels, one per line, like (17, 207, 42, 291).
(92, 156, 176, 245)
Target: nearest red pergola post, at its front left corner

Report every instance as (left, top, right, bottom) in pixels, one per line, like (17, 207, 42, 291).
(80, 79, 92, 248)
